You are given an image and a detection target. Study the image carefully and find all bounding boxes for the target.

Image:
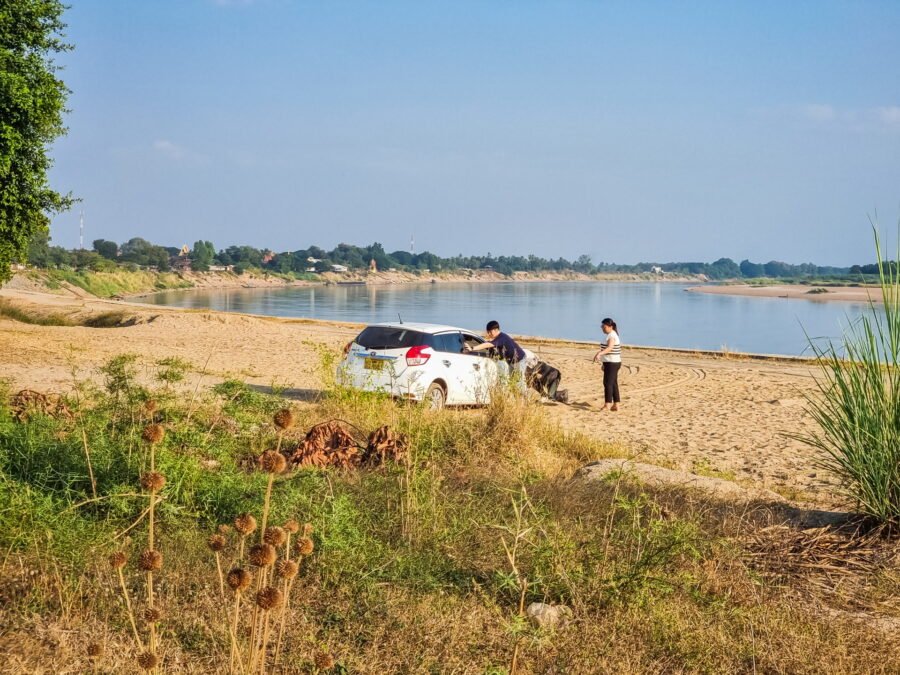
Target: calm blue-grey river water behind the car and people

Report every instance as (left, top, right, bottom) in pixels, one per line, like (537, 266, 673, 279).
(143, 282, 869, 356)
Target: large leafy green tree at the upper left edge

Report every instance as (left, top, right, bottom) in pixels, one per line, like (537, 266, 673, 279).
(0, 0, 72, 283)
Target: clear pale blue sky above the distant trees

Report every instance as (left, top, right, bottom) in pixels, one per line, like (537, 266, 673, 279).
(51, 0, 900, 265)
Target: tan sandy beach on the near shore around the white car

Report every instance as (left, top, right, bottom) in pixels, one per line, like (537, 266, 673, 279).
(0, 288, 834, 504)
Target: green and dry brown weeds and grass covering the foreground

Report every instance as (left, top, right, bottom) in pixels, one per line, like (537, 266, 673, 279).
(0, 328, 900, 673)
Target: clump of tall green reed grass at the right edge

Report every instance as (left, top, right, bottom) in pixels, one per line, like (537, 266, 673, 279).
(796, 227, 900, 523)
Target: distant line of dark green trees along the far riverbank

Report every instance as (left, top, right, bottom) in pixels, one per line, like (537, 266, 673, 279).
(17, 232, 897, 279)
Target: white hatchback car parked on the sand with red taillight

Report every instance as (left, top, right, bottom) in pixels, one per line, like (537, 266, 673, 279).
(337, 323, 509, 408)
